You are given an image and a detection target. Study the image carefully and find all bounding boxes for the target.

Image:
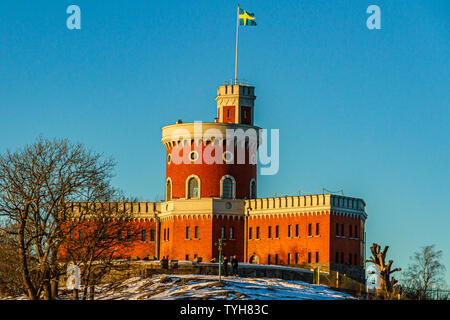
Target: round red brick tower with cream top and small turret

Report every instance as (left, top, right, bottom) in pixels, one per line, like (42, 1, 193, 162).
(161, 84, 260, 200)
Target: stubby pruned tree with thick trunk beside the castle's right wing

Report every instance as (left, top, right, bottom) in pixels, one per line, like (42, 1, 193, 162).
(365, 243, 402, 298)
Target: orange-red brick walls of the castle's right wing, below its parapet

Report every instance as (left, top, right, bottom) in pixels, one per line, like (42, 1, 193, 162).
(247, 212, 364, 266)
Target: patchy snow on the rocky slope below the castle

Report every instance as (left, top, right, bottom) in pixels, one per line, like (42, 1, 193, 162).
(2, 275, 354, 300)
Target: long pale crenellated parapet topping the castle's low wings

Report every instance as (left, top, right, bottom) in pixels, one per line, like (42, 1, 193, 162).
(66, 194, 367, 220)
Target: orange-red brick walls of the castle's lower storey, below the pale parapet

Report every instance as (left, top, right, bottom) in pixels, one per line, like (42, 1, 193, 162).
(91, 206, 364, 272)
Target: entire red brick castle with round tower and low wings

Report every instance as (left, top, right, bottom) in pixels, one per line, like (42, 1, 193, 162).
(68, 82, 367, 277)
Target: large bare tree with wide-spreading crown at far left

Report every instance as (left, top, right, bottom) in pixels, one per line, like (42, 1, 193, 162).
(0, 137, 118, 300)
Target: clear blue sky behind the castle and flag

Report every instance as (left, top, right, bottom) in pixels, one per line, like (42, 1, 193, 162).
(0, 0, 450, 283)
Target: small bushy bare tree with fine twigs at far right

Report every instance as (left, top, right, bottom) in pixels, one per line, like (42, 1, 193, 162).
(403, 244, 445, 300)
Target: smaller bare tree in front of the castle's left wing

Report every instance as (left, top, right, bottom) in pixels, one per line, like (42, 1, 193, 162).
(61, 199, 142, 300)
